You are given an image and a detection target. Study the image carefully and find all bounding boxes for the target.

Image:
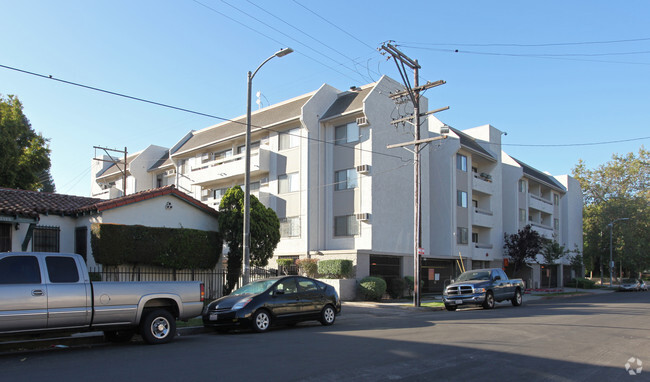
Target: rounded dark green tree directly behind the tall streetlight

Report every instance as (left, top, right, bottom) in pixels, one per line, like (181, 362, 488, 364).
(219, 186, 280, 293)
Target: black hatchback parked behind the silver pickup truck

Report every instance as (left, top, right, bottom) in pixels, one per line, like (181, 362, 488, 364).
(203, 276, 341, 333)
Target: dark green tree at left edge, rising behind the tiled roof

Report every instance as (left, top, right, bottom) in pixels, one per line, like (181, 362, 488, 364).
(0, 95, 54, 191)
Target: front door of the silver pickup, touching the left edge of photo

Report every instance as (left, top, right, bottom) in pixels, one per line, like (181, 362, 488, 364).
(0, 255, 47, 332)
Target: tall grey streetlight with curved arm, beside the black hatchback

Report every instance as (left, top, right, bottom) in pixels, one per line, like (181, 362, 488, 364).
(242, 48, 293, 285)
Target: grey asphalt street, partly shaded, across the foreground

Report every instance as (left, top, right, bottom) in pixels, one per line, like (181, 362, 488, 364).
(0, 292, 650, 382)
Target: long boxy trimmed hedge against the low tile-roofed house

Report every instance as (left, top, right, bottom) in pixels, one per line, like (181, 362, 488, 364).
(90, 223, 223, 269)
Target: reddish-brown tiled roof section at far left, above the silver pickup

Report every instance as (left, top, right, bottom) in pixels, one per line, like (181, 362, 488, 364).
(0, 188, 101, 219)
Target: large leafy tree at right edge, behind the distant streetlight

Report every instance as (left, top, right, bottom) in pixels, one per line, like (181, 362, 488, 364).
(573, 146, 650, 276)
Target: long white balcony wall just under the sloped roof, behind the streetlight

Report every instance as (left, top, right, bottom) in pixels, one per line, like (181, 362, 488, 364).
(187, 148, 271, 186)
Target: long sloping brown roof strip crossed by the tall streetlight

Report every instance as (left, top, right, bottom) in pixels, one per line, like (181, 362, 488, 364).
(172, 92, 314, 155)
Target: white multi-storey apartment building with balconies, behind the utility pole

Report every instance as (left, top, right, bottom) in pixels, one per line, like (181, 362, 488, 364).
(92, 76, 582, 291)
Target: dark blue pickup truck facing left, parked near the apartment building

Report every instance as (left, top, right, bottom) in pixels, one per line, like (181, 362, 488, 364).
(442, 268, 526, 311)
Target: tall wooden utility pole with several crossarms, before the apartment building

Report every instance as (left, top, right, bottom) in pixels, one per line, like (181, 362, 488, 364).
(380, 43, 449, 307)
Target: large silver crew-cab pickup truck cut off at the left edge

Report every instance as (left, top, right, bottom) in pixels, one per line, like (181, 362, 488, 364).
(0, 252, 204, 344)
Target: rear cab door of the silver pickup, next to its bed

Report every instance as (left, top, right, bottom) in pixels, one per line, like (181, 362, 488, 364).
(45, 255, 92, 328)
